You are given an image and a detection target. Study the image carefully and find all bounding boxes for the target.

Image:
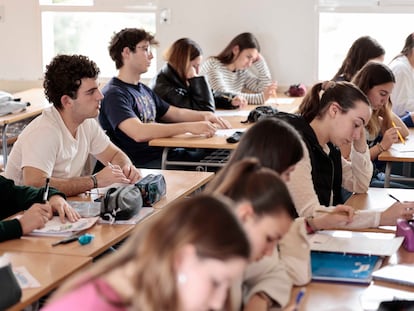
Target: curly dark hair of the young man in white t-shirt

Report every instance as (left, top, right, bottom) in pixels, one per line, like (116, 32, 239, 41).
(43, 55, 100, 109)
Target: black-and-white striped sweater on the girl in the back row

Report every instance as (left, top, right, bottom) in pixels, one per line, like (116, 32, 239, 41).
(200, 57, 272, 105)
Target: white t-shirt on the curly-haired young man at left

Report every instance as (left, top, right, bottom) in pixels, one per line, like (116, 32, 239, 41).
(5, 107, 110, 185)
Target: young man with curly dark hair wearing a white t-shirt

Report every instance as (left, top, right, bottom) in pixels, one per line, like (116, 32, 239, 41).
(5, 55, 140, 196)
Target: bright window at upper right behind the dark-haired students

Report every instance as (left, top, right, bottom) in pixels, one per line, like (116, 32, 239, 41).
(318, 0, 414, 80)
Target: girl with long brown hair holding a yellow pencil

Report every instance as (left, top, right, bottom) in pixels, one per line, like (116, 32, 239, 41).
(350, 61, 409, 188)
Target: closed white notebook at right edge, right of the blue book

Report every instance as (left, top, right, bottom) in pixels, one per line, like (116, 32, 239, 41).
(372, 264, 414, 286)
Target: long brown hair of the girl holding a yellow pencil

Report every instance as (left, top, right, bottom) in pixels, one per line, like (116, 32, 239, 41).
(352, 61, 395, 137)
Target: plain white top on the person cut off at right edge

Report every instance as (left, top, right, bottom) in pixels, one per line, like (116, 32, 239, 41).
(390, 56, 414, 117)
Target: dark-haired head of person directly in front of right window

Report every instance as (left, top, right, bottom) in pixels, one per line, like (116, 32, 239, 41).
(332, 36, 385, 82)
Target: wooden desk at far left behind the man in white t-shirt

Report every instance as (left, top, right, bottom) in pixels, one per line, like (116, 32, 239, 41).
(0, 88, 51, 167)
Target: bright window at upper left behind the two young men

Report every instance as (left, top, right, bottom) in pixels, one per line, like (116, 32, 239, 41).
(39, 0, 156, 78)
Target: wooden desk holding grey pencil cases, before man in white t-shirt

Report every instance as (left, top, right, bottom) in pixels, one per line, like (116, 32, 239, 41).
(0, 169, 214, 257)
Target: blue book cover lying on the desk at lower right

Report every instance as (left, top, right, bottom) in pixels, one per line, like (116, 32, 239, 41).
(311, 251, 382, 284)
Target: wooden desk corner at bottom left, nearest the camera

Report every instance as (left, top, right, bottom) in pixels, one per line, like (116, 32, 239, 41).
(0, 251, 92, 311)
